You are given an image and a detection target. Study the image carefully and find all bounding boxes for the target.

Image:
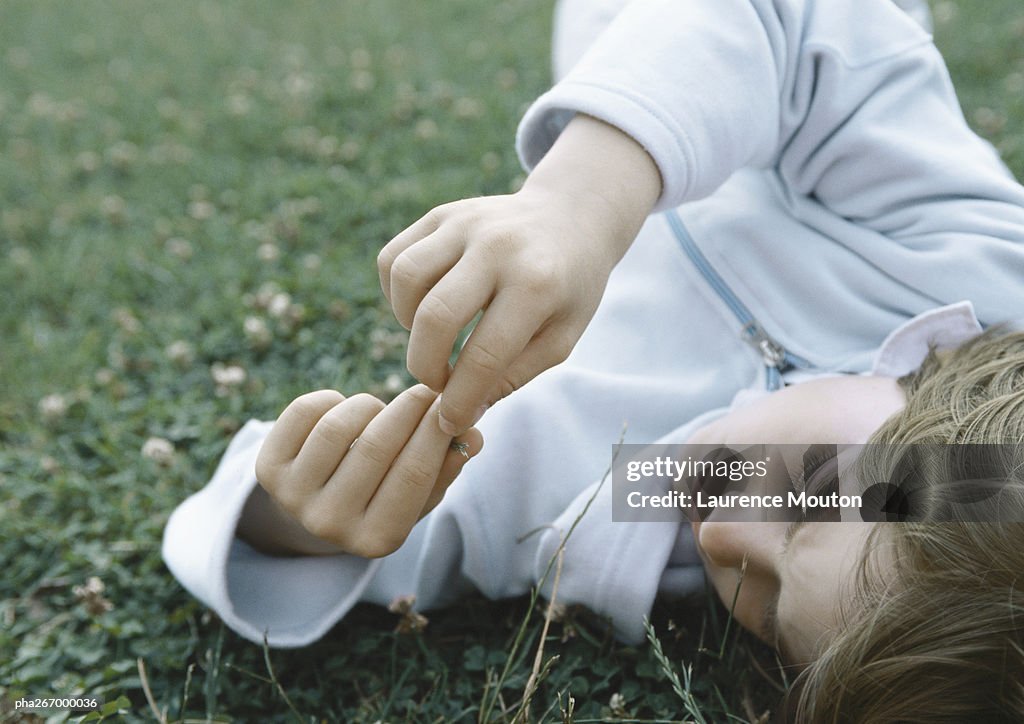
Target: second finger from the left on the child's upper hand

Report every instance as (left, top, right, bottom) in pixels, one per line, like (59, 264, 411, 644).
(389, 225, 465, 330)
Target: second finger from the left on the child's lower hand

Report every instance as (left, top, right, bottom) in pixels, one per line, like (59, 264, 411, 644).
(282, 394, 384, 507)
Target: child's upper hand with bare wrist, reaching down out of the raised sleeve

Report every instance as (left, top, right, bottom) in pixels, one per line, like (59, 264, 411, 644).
(378, 117, 660, 435)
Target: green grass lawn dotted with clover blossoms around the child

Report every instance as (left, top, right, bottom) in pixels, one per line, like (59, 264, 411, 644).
(0, 0, 1024, 722)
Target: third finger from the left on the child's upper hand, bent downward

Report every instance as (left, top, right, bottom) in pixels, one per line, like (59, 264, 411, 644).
(407, 257, 495, 393)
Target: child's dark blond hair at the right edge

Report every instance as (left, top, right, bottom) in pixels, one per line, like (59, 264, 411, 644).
(784, 329, 1024, 724)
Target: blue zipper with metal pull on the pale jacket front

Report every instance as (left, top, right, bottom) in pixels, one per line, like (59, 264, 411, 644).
(666, 209, 811, 390)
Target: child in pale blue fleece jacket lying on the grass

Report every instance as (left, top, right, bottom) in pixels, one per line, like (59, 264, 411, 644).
(164, 0, 1024, 722)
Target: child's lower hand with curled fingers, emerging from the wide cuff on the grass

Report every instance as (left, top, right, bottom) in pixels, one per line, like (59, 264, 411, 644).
(256, 385, 482, 558)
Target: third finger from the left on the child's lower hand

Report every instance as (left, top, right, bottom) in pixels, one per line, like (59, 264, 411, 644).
(317, 385, 437, 503)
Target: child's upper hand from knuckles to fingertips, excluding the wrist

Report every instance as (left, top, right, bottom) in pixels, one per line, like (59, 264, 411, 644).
(379, 189, 617, 434)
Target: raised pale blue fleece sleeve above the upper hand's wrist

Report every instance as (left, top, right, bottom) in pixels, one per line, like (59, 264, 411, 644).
(517, 0, 1022, 215)
